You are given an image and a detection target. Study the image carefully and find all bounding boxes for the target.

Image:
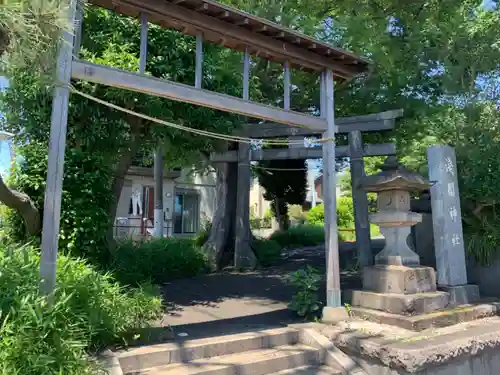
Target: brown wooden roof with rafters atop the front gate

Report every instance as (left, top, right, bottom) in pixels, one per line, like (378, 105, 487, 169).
(90, 0, 371, 79)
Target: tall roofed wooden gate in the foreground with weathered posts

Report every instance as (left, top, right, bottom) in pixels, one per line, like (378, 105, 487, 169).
(40, 0, 370, 318)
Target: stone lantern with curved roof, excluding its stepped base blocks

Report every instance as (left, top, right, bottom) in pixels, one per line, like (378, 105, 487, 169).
(361, 156, 431, 266)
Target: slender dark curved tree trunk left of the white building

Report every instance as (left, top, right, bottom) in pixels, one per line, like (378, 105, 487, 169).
(108, 117, 143, 244)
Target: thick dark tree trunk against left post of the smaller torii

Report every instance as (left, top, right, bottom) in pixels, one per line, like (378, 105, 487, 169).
(203, 163, 238, 271)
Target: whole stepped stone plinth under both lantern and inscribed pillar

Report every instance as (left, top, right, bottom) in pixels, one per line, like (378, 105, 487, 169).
(347, 265, 492, 331)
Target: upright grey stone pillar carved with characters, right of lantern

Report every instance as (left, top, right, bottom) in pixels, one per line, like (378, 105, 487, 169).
(427, 145, 467, 286)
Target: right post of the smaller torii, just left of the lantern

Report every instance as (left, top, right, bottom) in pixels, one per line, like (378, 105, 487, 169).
(349, 131, 373, 268)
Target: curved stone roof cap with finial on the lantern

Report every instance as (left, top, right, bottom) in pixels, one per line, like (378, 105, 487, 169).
(361, 156, 431, 193)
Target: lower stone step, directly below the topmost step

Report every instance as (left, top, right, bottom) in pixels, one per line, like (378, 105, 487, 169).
(135, 344, 320, 375)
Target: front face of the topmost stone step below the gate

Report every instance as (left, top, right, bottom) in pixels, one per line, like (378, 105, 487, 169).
(115, 327, 299, 372)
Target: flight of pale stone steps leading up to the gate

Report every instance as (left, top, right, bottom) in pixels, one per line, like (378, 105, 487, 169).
(116, 328, 342, 375)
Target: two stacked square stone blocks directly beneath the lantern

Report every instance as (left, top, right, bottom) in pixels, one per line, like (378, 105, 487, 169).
(351, 265, 450, 315)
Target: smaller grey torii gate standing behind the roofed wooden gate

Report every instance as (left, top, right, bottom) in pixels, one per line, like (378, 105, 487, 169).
(210, 110, 403, 267)
